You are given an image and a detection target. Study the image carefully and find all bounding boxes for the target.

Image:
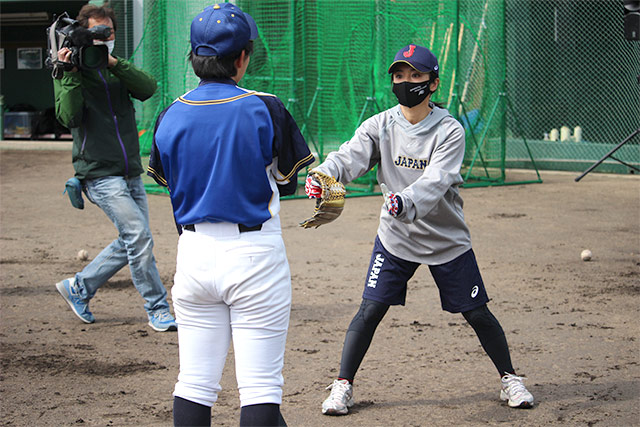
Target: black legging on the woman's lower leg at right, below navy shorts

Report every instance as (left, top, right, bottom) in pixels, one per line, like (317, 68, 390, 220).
(462, 305, 515, 376)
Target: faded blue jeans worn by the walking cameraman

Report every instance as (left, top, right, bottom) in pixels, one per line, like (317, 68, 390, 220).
(76, 176, 169, 316)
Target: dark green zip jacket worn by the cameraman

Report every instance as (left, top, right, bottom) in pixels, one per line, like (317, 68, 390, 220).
(53, 58, 157, 180)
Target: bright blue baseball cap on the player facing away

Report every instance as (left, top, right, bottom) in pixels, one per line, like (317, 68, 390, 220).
(191, 3, 258, 57)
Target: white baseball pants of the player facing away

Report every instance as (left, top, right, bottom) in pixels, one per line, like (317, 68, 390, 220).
(171, 218, 291, 406)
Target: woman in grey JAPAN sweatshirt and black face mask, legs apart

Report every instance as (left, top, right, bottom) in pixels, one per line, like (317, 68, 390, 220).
(305, 44, 533, 415)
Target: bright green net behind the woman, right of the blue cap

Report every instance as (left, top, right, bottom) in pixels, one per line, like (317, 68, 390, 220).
(238, 0, 524, 189)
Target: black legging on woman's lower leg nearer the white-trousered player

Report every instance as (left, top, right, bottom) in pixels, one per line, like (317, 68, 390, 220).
(338, 299, 389, 382)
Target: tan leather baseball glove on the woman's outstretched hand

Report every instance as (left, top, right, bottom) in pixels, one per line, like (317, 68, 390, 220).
(300, 171, 347, 228)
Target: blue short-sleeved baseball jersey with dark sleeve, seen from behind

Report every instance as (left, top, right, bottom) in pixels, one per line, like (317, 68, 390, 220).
(148, 79, 314, 226)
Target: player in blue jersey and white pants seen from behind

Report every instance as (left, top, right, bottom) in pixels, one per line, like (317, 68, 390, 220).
(149, 3, 314, 426)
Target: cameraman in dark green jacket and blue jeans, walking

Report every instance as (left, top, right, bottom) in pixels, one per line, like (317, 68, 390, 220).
(54, 4, 177, 332)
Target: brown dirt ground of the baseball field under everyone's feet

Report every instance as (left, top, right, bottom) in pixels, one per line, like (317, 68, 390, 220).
(0, 150, 640, 426)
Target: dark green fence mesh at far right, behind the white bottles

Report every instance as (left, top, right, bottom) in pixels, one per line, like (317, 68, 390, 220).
(506, 0, 640, 173)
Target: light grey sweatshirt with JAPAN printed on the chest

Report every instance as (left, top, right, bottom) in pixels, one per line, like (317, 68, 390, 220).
(314, 105, 471, 265)
